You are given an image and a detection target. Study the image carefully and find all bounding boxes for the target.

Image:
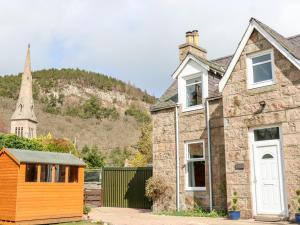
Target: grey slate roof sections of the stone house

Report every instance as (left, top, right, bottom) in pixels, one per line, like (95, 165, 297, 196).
(150, 18, 300, 112)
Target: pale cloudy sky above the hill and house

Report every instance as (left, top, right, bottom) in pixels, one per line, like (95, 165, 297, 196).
(0, 0, 300, 97)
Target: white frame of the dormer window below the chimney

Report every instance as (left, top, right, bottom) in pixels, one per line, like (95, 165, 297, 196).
(182, 72, 204, 112)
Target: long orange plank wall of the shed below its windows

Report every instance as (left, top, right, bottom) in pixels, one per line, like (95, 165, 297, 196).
(16, 164, 84, 221)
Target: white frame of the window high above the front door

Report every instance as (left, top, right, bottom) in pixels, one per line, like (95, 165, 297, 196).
(247, 49, 275, 89)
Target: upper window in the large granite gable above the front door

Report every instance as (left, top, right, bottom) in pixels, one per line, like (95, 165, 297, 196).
(248, 51, 274, 88)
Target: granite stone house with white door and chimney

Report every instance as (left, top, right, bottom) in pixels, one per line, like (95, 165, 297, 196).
(151, 18, 300, 218)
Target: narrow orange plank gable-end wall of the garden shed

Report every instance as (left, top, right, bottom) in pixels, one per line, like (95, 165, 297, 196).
(0, 153, 19, 220)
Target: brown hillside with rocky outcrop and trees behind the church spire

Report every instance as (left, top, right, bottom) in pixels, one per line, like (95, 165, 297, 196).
(0, 69, 155, 150)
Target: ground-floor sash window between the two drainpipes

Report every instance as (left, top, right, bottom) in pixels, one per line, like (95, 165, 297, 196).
(185, 141, 205, 191)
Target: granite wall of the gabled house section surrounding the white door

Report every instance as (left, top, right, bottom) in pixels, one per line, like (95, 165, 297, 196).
(222, 31, 300, 218)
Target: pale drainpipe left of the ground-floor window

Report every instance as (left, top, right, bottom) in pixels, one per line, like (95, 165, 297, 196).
(175, 103, 180, 212)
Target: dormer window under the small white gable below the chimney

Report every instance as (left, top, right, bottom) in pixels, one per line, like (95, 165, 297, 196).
(186, 76, 202, 107)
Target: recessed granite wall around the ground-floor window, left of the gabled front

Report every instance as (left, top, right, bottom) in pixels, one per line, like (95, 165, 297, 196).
(152, 99, 226, 211)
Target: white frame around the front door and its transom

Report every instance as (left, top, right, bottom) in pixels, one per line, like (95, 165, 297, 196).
(248, 124, 288, 216)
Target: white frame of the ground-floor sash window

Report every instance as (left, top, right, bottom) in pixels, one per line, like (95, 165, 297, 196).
(184, 140, 206, 191)
